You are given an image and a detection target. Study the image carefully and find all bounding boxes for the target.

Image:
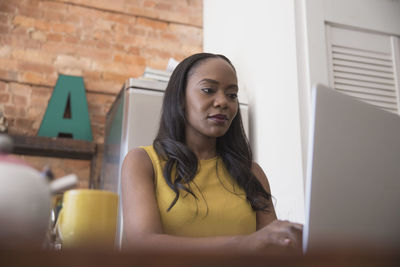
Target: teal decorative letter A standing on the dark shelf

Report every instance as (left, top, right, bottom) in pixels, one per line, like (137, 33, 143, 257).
(38, 74, 93, 141)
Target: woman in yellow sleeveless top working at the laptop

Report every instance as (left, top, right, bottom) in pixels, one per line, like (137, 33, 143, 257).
(122, 53, 302, 252)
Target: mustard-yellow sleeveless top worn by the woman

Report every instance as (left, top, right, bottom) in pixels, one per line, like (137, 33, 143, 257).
(142, 146, 256, 237)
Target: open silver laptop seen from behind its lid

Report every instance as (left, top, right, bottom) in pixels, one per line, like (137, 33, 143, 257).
(303, 85, 400, 252)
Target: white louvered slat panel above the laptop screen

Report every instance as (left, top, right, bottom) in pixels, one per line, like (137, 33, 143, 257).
(328, 26, 398, 113)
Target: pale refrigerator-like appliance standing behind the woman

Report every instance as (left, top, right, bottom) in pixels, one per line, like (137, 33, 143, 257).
(100, 78, 249, 247)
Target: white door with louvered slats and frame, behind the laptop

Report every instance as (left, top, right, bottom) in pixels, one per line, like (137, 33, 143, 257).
(296, 0, 400, 177)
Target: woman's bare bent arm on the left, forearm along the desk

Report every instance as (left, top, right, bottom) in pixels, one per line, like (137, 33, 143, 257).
(122, 148, 300, 252)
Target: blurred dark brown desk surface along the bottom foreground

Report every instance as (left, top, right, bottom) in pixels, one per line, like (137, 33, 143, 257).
(0, 250, 400, 267)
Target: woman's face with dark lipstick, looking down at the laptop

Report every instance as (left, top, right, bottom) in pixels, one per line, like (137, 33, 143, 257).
(185, 58, 239, 140)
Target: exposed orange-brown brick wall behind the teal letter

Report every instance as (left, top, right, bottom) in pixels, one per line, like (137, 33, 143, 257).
(0, 0, 202, 188)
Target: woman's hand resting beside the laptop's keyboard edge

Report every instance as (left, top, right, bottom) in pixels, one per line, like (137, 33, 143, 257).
(242, 220, 303, 253)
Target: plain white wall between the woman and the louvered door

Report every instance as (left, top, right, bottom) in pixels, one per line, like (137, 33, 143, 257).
(203, 0, 304, 223)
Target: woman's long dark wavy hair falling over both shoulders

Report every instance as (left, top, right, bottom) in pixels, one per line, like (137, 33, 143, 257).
(153, 53, 271, 214)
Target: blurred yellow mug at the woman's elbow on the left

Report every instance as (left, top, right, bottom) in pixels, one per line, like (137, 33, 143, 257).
(57, 189, 118, 249)
